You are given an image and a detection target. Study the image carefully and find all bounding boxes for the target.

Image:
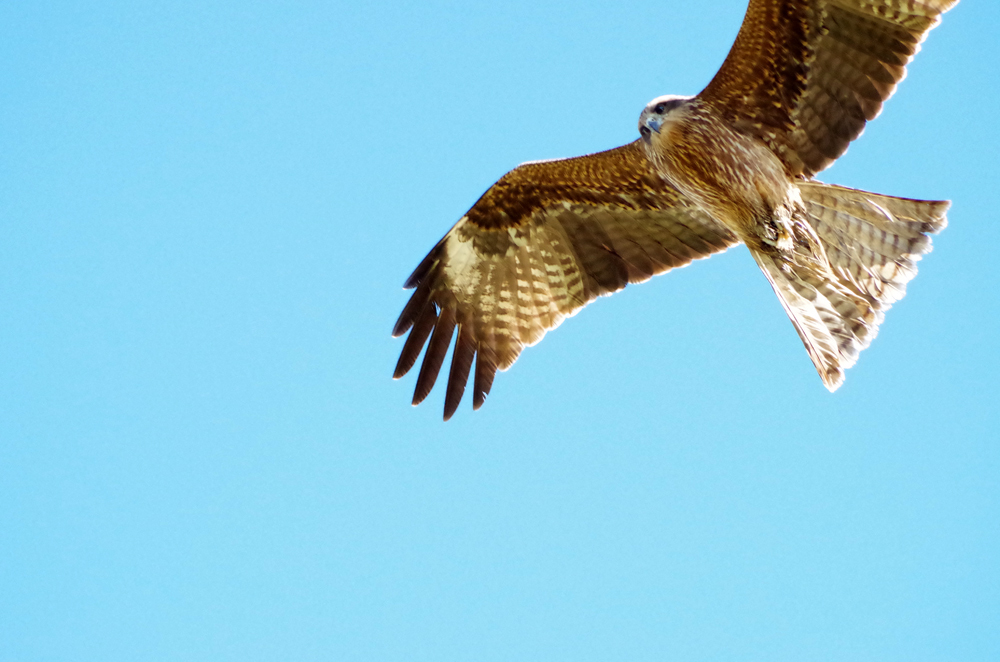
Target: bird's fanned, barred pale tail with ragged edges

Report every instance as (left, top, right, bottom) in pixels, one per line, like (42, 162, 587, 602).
(751, 182, 950, 391)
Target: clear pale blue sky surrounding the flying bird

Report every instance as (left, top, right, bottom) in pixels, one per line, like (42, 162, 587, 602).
(0, 0, 1000, 662)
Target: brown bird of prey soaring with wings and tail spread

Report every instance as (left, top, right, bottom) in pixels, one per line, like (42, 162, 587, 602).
(393, 0, 958, 420)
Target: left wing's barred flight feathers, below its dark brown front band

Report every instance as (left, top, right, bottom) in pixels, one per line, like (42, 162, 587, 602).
(394, 202, 736, 417)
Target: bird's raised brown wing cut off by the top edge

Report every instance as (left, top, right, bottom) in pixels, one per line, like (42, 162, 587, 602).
(698, 0, 958, 177)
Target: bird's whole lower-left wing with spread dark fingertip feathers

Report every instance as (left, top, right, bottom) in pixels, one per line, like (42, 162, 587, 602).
(393, 142, 737, 420)
